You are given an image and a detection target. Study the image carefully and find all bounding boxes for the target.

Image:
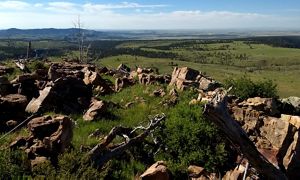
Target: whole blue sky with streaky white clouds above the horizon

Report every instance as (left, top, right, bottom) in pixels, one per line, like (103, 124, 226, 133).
(0, 0, 300, 30)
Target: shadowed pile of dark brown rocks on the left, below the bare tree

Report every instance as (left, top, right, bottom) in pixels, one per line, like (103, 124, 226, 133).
(0, 63, 119, 131)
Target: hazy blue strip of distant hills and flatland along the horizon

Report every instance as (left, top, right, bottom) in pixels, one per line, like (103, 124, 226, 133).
(0, 28, 300, 40)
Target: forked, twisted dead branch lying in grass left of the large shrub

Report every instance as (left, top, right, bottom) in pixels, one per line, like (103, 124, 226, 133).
(88, 114, 165, 168)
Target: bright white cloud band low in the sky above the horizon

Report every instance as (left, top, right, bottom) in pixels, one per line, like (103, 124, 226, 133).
(0, 1, 300, 29)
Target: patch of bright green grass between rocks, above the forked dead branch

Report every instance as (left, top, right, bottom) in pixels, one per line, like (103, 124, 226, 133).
(73, 84, 165, 147)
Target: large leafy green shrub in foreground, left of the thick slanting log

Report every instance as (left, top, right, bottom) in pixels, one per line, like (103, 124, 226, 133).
(156, 90, 227, 178)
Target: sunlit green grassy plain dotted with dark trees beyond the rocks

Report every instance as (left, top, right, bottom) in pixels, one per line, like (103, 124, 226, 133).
(96, 41, 300, 97)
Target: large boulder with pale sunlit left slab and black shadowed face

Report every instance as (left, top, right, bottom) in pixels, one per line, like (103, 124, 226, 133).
(26, 76, 92, 113)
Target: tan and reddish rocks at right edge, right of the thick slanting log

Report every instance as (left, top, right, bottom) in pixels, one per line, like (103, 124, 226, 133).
(229, 97, 300, 179)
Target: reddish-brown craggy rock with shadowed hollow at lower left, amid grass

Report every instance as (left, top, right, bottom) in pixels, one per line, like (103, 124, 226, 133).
(10, 115, 74, 165)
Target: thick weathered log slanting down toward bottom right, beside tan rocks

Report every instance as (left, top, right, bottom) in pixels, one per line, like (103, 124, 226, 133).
(204, 89, 287, 179)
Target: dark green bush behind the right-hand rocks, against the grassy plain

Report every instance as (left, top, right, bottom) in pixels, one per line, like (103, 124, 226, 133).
(225, 76, 278, 99)
